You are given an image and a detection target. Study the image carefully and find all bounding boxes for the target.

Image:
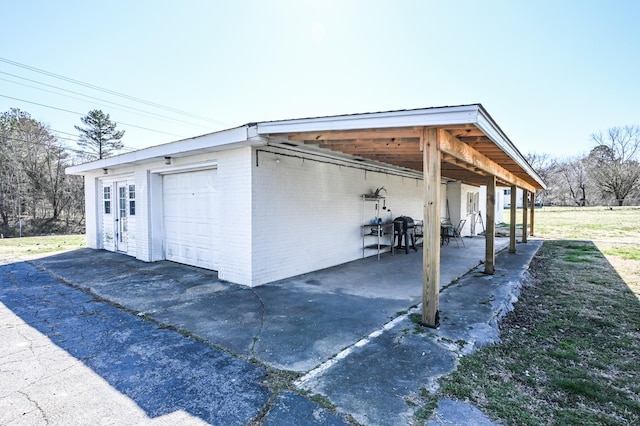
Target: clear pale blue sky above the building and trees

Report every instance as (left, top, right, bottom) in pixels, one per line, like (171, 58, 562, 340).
(0, 0, 640, 157)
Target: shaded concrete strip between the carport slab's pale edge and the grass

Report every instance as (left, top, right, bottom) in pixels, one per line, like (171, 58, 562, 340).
(297, 241, 540, 425)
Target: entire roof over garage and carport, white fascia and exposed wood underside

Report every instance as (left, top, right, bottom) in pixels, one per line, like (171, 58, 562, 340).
(67, 104, 545, 191)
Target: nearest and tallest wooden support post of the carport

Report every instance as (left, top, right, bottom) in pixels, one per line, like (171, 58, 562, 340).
(420, 128, 441, 328)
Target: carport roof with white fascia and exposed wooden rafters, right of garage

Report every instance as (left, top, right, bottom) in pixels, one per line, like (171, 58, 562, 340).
(257, 104, 545, 191)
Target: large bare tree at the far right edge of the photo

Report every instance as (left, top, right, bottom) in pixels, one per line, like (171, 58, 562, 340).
(588, 126, 640, 206)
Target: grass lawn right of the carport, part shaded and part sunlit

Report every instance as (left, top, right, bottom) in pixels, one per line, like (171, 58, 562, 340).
(416, 207, 640, 425)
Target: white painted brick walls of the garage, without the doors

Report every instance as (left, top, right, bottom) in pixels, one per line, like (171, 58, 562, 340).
(85, 147, 490, 286)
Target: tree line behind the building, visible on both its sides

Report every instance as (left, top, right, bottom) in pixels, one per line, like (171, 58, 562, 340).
(0, 108, 640, 236)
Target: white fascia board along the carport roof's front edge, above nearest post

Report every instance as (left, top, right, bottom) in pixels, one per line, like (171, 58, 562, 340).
(258, 104, 479, 135)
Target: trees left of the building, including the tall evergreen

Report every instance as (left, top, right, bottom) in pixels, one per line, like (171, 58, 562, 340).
(0, 108, 124, 237)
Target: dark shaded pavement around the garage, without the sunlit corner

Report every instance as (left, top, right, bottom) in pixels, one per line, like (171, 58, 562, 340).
(0, 239, 539, 424)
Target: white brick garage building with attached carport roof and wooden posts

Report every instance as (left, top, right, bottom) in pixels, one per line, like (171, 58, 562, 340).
(67, 104, 544, 325)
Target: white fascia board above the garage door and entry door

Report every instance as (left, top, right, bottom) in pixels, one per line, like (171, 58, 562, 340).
(66, 126, 266, 175)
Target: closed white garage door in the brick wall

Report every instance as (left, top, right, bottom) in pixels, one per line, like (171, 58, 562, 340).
(163, 170, 219, 269)
